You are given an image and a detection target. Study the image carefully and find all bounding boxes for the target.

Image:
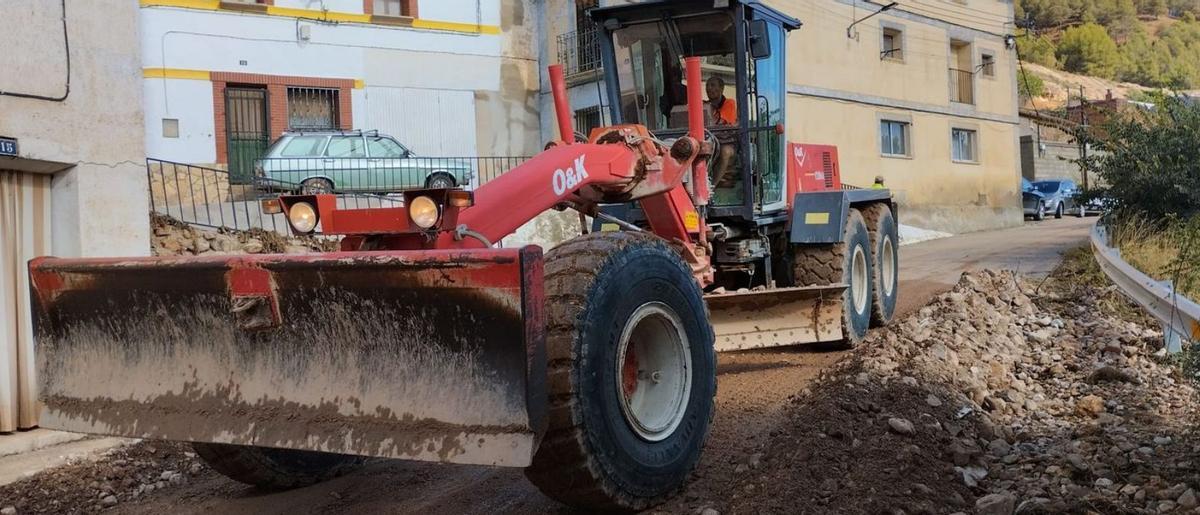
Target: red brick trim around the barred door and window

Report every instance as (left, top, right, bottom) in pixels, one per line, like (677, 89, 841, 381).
(209, 72, 354, 163)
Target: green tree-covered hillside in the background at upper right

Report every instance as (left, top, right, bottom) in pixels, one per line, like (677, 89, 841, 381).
(1015, 0, 1200, 90)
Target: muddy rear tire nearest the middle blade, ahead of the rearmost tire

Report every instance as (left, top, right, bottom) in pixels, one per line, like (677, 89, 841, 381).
(792, 209, 874, 349)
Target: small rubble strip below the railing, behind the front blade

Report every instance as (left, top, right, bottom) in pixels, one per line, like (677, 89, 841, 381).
(150, 212, 337, 256)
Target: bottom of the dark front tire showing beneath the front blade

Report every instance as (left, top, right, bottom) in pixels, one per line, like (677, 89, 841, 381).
(192, 443, 366, 490)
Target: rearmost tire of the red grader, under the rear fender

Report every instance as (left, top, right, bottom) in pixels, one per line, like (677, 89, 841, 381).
(862, 202, 900, 328)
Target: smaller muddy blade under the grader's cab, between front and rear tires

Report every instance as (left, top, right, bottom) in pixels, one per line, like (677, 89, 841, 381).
(704, 285, 846, 352)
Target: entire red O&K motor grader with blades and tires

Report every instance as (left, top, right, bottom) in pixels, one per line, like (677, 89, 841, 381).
(30, 0, 896, 509)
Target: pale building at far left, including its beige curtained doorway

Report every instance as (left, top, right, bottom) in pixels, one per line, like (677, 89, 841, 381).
(0, 0, 149, 433)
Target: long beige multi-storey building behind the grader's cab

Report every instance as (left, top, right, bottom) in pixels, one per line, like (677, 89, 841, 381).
(541, 0, 1022, 233)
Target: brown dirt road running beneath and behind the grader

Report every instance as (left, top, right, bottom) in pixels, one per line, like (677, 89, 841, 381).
(116, 217, 1096, 515)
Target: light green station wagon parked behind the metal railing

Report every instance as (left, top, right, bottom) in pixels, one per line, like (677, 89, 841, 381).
(256, 131, 474, 194)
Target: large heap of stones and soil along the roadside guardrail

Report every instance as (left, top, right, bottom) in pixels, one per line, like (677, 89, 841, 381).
(705, 266, 1200, 515)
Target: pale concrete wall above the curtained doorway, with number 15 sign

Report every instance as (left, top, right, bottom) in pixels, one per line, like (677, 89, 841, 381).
(0, 0, 150, 256)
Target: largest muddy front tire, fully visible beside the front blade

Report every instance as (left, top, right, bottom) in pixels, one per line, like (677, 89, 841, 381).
(526, 232, 716, 511)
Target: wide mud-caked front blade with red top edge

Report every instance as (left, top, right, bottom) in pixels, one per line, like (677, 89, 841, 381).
(30, 247, 546, 467)
